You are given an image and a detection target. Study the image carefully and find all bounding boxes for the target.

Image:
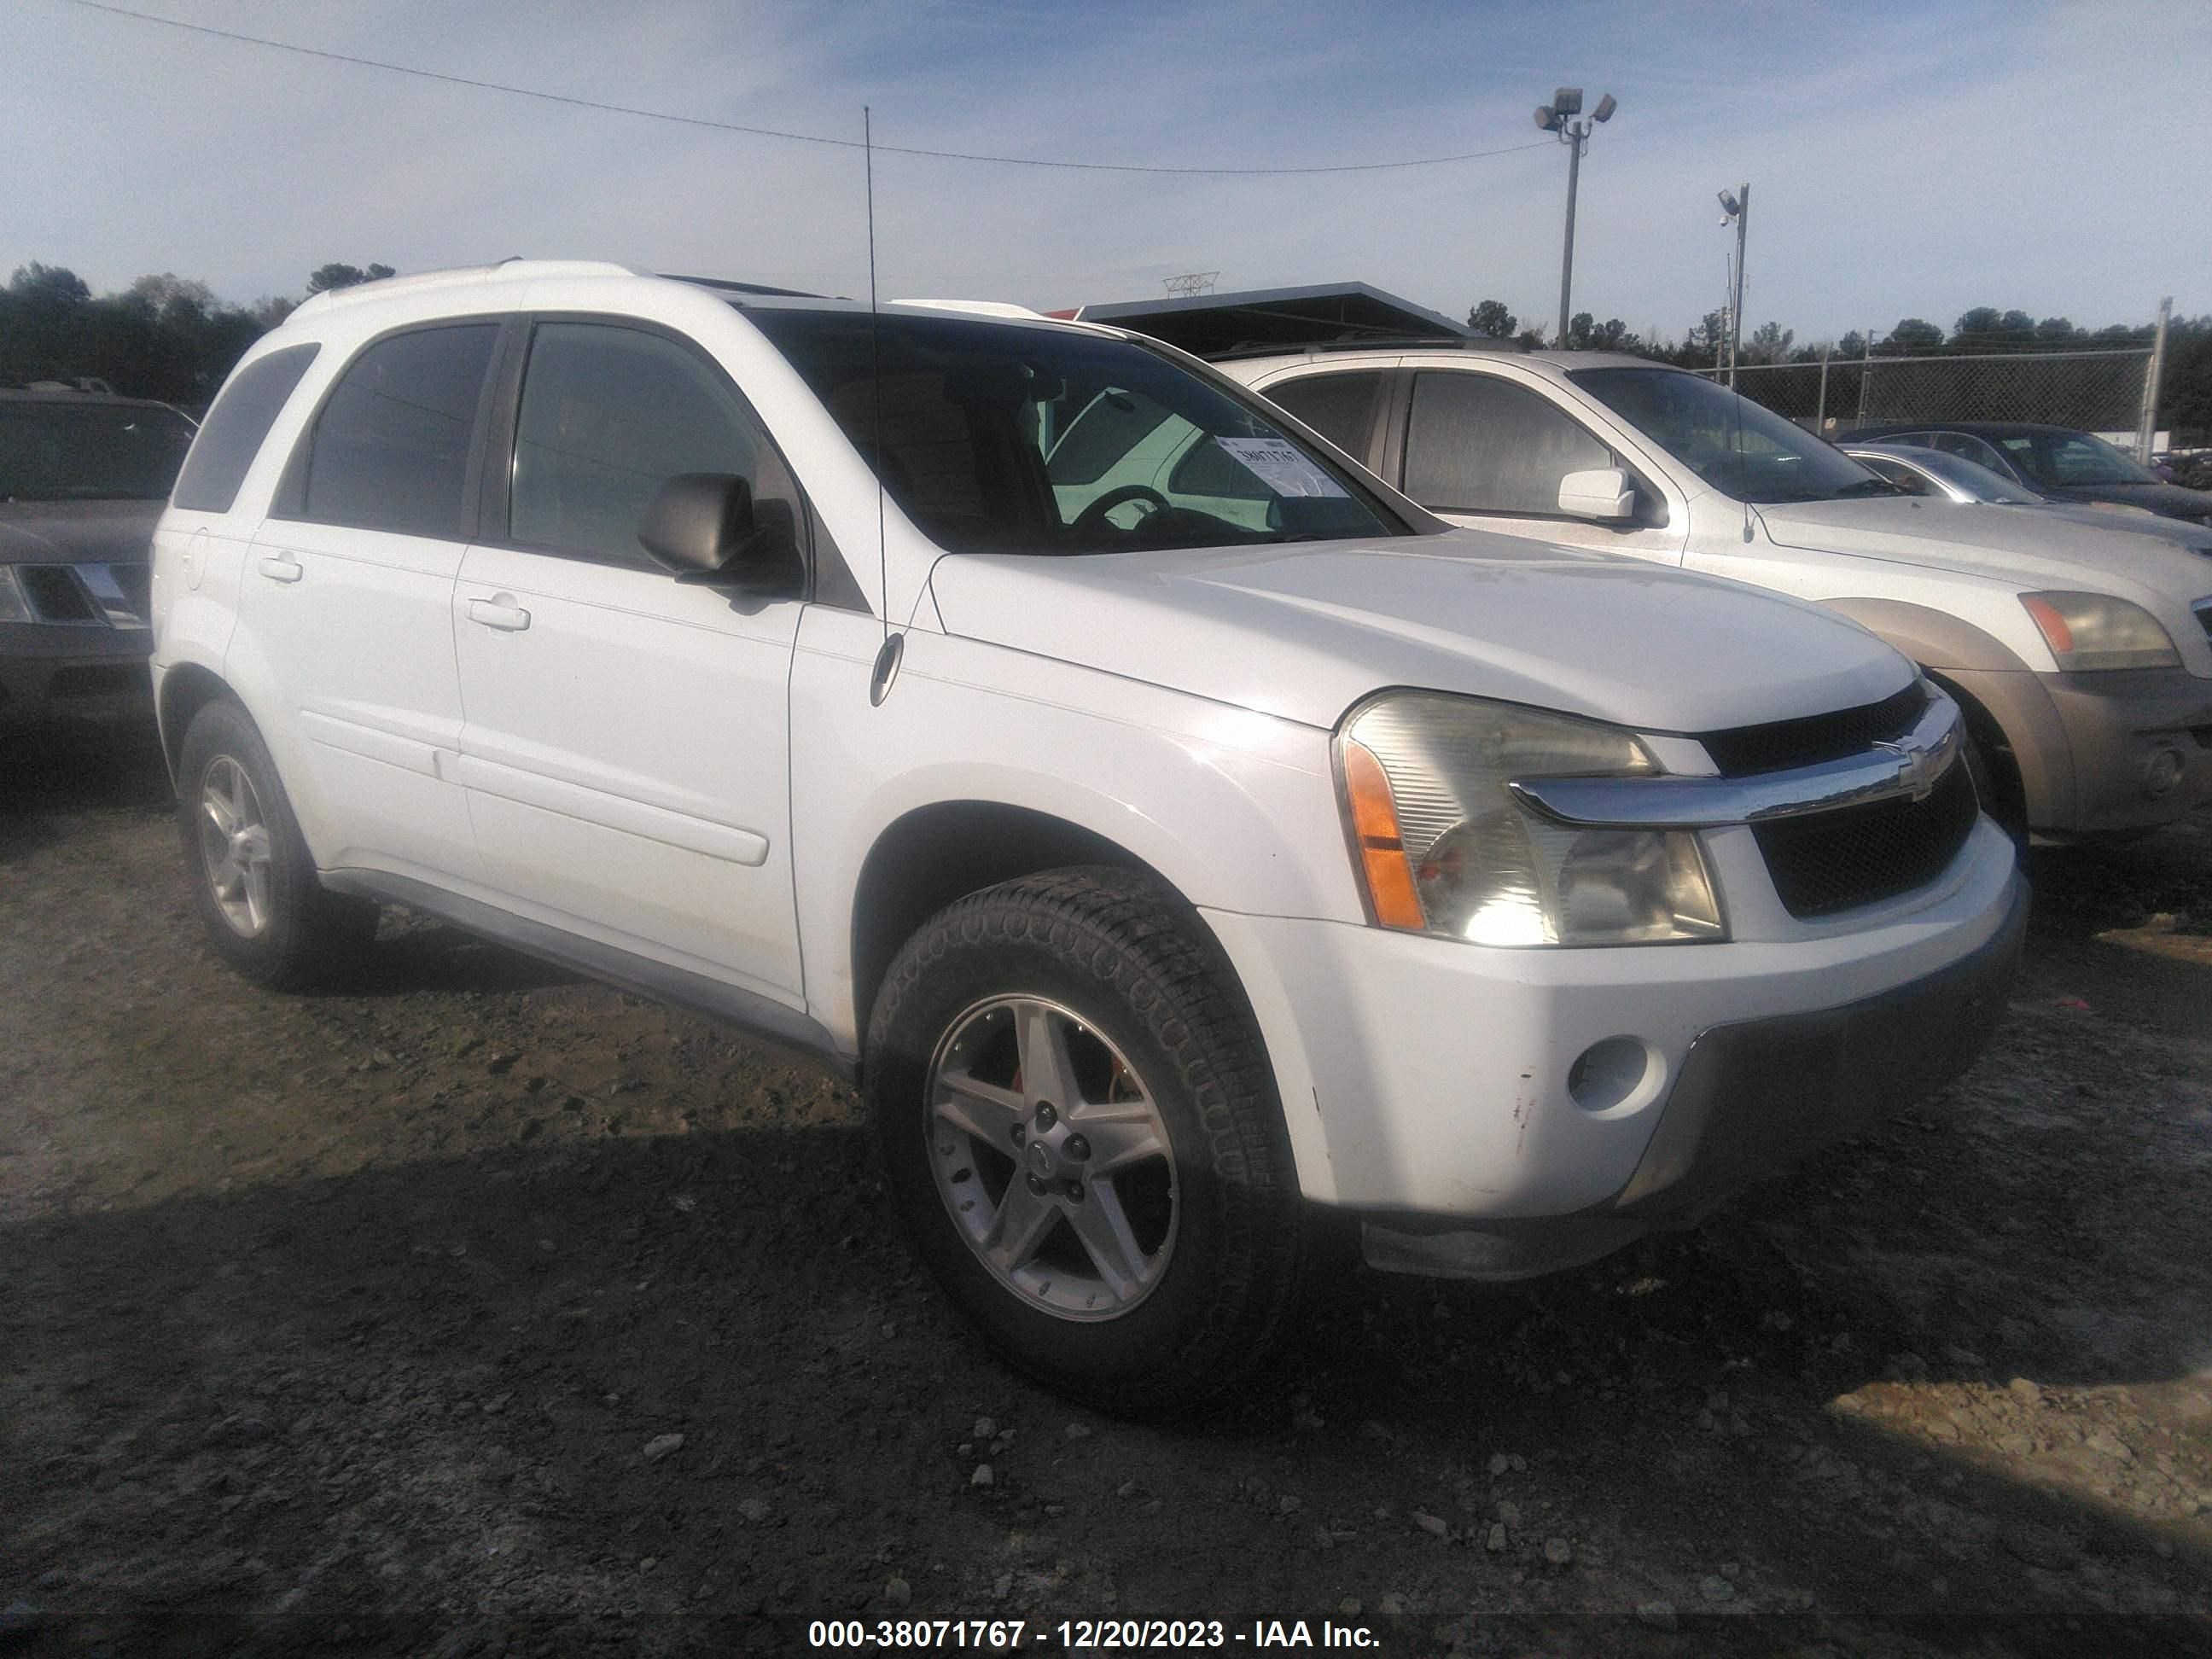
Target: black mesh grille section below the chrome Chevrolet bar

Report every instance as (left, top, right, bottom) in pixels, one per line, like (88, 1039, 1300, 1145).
(1752, 761, 1980, 918)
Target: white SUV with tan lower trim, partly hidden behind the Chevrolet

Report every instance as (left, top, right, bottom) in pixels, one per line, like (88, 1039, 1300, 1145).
(1221, 343, 2212, 843)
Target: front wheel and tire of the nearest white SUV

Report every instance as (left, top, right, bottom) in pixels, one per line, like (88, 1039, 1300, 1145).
(864, 867, 1305, 1416)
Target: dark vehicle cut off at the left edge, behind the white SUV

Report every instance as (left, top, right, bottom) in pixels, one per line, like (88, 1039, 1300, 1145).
(0, 387, 193, 725)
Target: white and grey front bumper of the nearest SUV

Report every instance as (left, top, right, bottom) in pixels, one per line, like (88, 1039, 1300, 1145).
(1206, 818, 2026, 1254)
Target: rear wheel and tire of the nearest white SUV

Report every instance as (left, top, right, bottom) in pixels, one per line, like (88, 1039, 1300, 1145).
(177, 699, 376, 991)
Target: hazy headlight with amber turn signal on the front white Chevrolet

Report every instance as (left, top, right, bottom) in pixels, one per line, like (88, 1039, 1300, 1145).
(1338, 692, 1727, 945)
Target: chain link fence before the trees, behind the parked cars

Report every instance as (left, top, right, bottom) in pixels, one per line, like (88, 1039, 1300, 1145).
(1699, 350, 2150, 445)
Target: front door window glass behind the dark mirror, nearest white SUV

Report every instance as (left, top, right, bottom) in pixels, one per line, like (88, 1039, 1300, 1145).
(507, 323, 781, 564)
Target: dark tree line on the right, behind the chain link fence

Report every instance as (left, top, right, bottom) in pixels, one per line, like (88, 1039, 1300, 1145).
(1466, 299, 2212, 445)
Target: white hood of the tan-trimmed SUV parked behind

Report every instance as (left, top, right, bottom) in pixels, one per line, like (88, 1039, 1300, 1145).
(1752, 498, 2212, 610)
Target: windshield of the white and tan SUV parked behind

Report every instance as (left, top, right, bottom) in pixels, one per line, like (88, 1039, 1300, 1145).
(1566, 370, 1898, 502)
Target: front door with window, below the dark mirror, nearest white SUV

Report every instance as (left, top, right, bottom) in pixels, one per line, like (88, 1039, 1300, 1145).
(451, 317, 805, 1006)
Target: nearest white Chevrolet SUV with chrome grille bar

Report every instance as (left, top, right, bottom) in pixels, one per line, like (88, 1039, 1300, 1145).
(153, 263, 2024, 1409)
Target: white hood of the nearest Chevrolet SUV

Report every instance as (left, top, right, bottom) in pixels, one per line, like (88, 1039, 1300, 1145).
(931, 531, 1913, 732)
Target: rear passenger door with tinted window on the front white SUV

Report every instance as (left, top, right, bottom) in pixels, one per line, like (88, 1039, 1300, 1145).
(232, 318, 504, 882)
